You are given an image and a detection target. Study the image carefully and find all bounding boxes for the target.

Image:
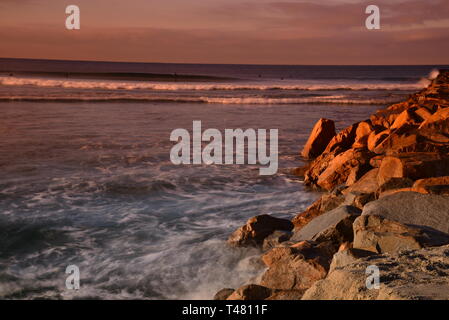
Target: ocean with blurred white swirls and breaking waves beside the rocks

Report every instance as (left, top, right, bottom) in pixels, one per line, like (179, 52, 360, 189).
(0, 59, 447, 299)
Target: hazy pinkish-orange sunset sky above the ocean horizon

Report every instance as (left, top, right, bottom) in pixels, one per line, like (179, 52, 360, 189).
(0, 0, 449, 64)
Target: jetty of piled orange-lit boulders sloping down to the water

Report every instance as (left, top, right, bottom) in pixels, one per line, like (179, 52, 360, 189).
(215, 70, 449, 300)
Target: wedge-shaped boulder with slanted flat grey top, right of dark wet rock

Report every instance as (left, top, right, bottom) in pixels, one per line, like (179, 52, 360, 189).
(291, 206, 362, 248)
